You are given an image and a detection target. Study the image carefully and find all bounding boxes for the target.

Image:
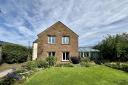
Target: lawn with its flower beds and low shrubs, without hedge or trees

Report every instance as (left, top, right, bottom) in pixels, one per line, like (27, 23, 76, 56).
(0, 56, 128, 85)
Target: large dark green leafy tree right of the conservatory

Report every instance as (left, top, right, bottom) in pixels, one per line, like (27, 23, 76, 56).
(95, 33, 128, 61)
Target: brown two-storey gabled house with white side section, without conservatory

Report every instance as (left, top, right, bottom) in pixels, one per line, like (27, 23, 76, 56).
(32, 21, 79, 63)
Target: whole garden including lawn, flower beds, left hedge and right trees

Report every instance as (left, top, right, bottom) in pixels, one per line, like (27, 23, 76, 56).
(0, 33, 128, 85)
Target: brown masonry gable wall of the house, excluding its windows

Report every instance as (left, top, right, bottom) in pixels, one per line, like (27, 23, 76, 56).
(37, 22, 78, 63)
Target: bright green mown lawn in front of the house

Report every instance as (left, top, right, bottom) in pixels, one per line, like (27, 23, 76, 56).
(23, 66, 128, 85)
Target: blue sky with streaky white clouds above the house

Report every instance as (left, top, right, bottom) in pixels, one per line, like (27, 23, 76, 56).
(0, 0, 128, 46)
